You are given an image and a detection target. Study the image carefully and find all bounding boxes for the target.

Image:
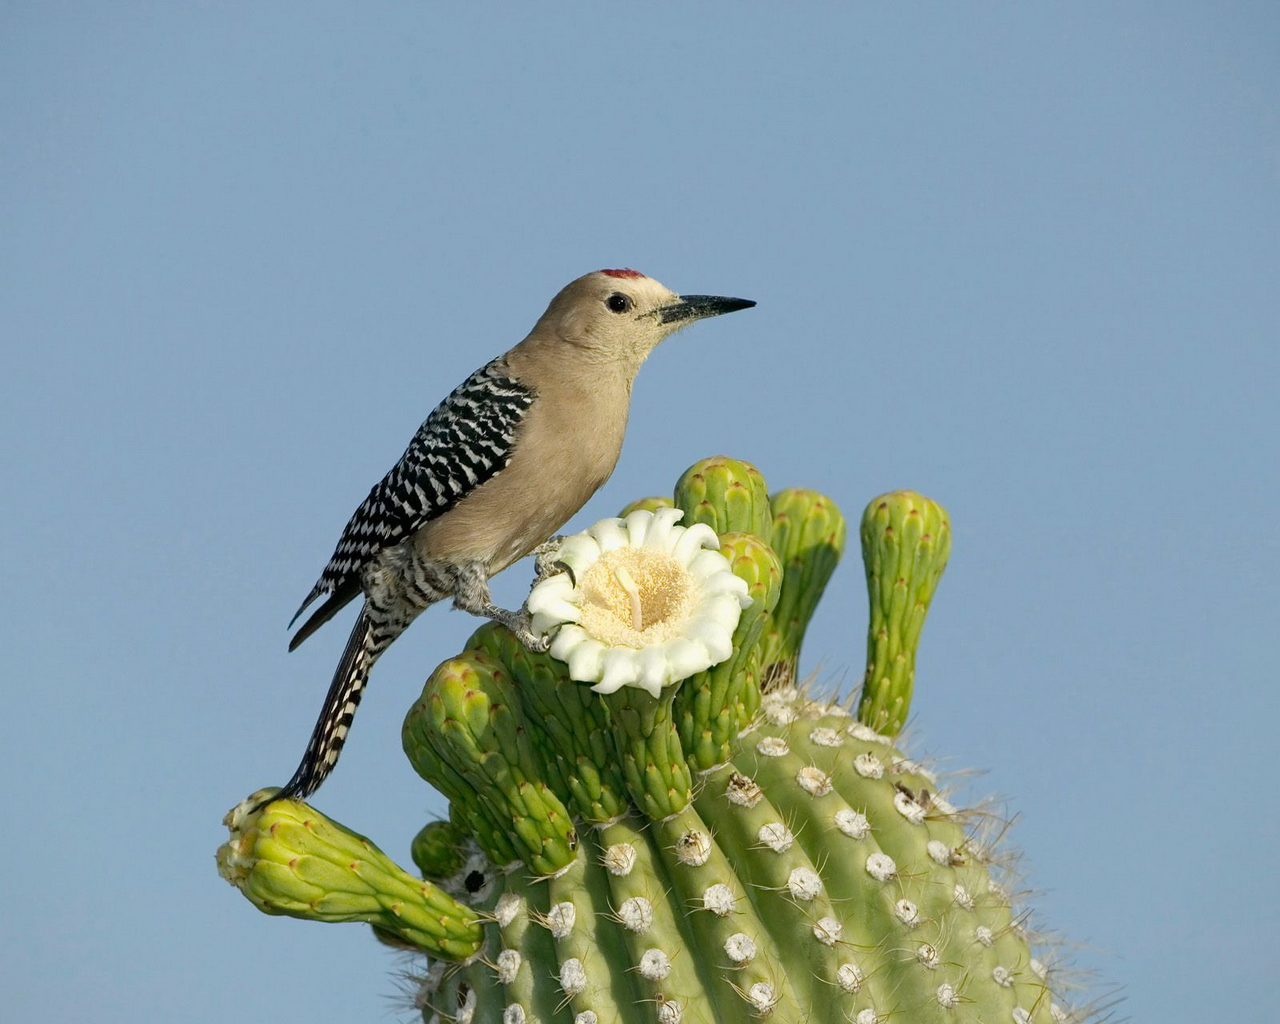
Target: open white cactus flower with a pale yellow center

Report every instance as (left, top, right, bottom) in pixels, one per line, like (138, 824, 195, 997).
(525, 508, 751, 696)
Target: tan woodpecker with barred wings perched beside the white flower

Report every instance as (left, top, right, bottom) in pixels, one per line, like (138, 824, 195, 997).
(274, 270, 755, 800)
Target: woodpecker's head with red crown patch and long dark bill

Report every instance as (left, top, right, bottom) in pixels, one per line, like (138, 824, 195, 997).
(534, 270, 755, 372)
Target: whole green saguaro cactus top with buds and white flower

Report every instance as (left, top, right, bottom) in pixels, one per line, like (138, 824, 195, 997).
(218, 457, 1089, 1024)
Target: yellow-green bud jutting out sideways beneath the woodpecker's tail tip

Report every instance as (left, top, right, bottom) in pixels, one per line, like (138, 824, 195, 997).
(218, 790, 481, 959)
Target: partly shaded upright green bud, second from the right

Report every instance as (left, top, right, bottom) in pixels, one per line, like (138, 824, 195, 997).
(760, 489, 846, 690)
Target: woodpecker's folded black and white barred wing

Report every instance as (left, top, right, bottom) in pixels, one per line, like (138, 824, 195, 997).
(294, 358, 535, 627)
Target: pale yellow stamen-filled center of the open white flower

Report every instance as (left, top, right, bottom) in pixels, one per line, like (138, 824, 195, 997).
(579, 548, 696, 650)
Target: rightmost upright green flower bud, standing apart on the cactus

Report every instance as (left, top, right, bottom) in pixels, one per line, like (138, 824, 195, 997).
(858, 490, 951, 736)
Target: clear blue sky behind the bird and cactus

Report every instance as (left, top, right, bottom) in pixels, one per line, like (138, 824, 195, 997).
(0, 0, 1280, 1024)
